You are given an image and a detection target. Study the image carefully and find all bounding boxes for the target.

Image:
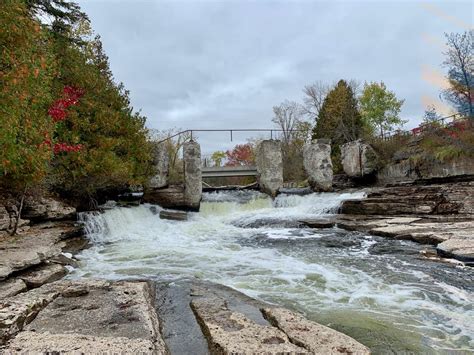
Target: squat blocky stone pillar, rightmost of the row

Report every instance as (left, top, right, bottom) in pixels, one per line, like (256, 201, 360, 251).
(341, 139, 378, 178)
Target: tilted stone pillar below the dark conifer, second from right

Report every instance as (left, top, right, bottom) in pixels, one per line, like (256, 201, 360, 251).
(303, 139, 333, 191)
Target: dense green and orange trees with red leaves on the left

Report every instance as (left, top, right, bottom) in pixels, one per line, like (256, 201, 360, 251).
(0, 0, 151, 197)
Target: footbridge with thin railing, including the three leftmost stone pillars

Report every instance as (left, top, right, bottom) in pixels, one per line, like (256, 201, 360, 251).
(144, 129, 308, 210)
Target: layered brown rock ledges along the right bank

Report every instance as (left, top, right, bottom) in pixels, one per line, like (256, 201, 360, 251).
(336, 181, 474, 264)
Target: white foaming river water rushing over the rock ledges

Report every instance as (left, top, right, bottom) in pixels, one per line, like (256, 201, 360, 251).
(72, 192, 474, 353)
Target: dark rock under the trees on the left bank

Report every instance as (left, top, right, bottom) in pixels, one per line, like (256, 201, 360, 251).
(21, 196, 76, 222)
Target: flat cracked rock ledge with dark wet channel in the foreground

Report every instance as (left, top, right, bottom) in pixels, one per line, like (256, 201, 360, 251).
(0, 280, 370, 354)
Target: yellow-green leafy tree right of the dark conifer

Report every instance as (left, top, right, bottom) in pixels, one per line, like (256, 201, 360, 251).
(360, 82, 406, 137)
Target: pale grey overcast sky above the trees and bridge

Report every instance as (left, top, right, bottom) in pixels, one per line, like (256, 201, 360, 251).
(79, 0, 473, 152)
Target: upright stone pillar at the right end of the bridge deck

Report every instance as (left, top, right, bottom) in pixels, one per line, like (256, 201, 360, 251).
(256, 140, 283, 197)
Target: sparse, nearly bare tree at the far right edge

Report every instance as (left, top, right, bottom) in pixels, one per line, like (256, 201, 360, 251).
(443, 30, 474, 117)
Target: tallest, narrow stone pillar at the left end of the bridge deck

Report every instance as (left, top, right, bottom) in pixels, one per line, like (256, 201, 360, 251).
(183, 141, 202, 211)
